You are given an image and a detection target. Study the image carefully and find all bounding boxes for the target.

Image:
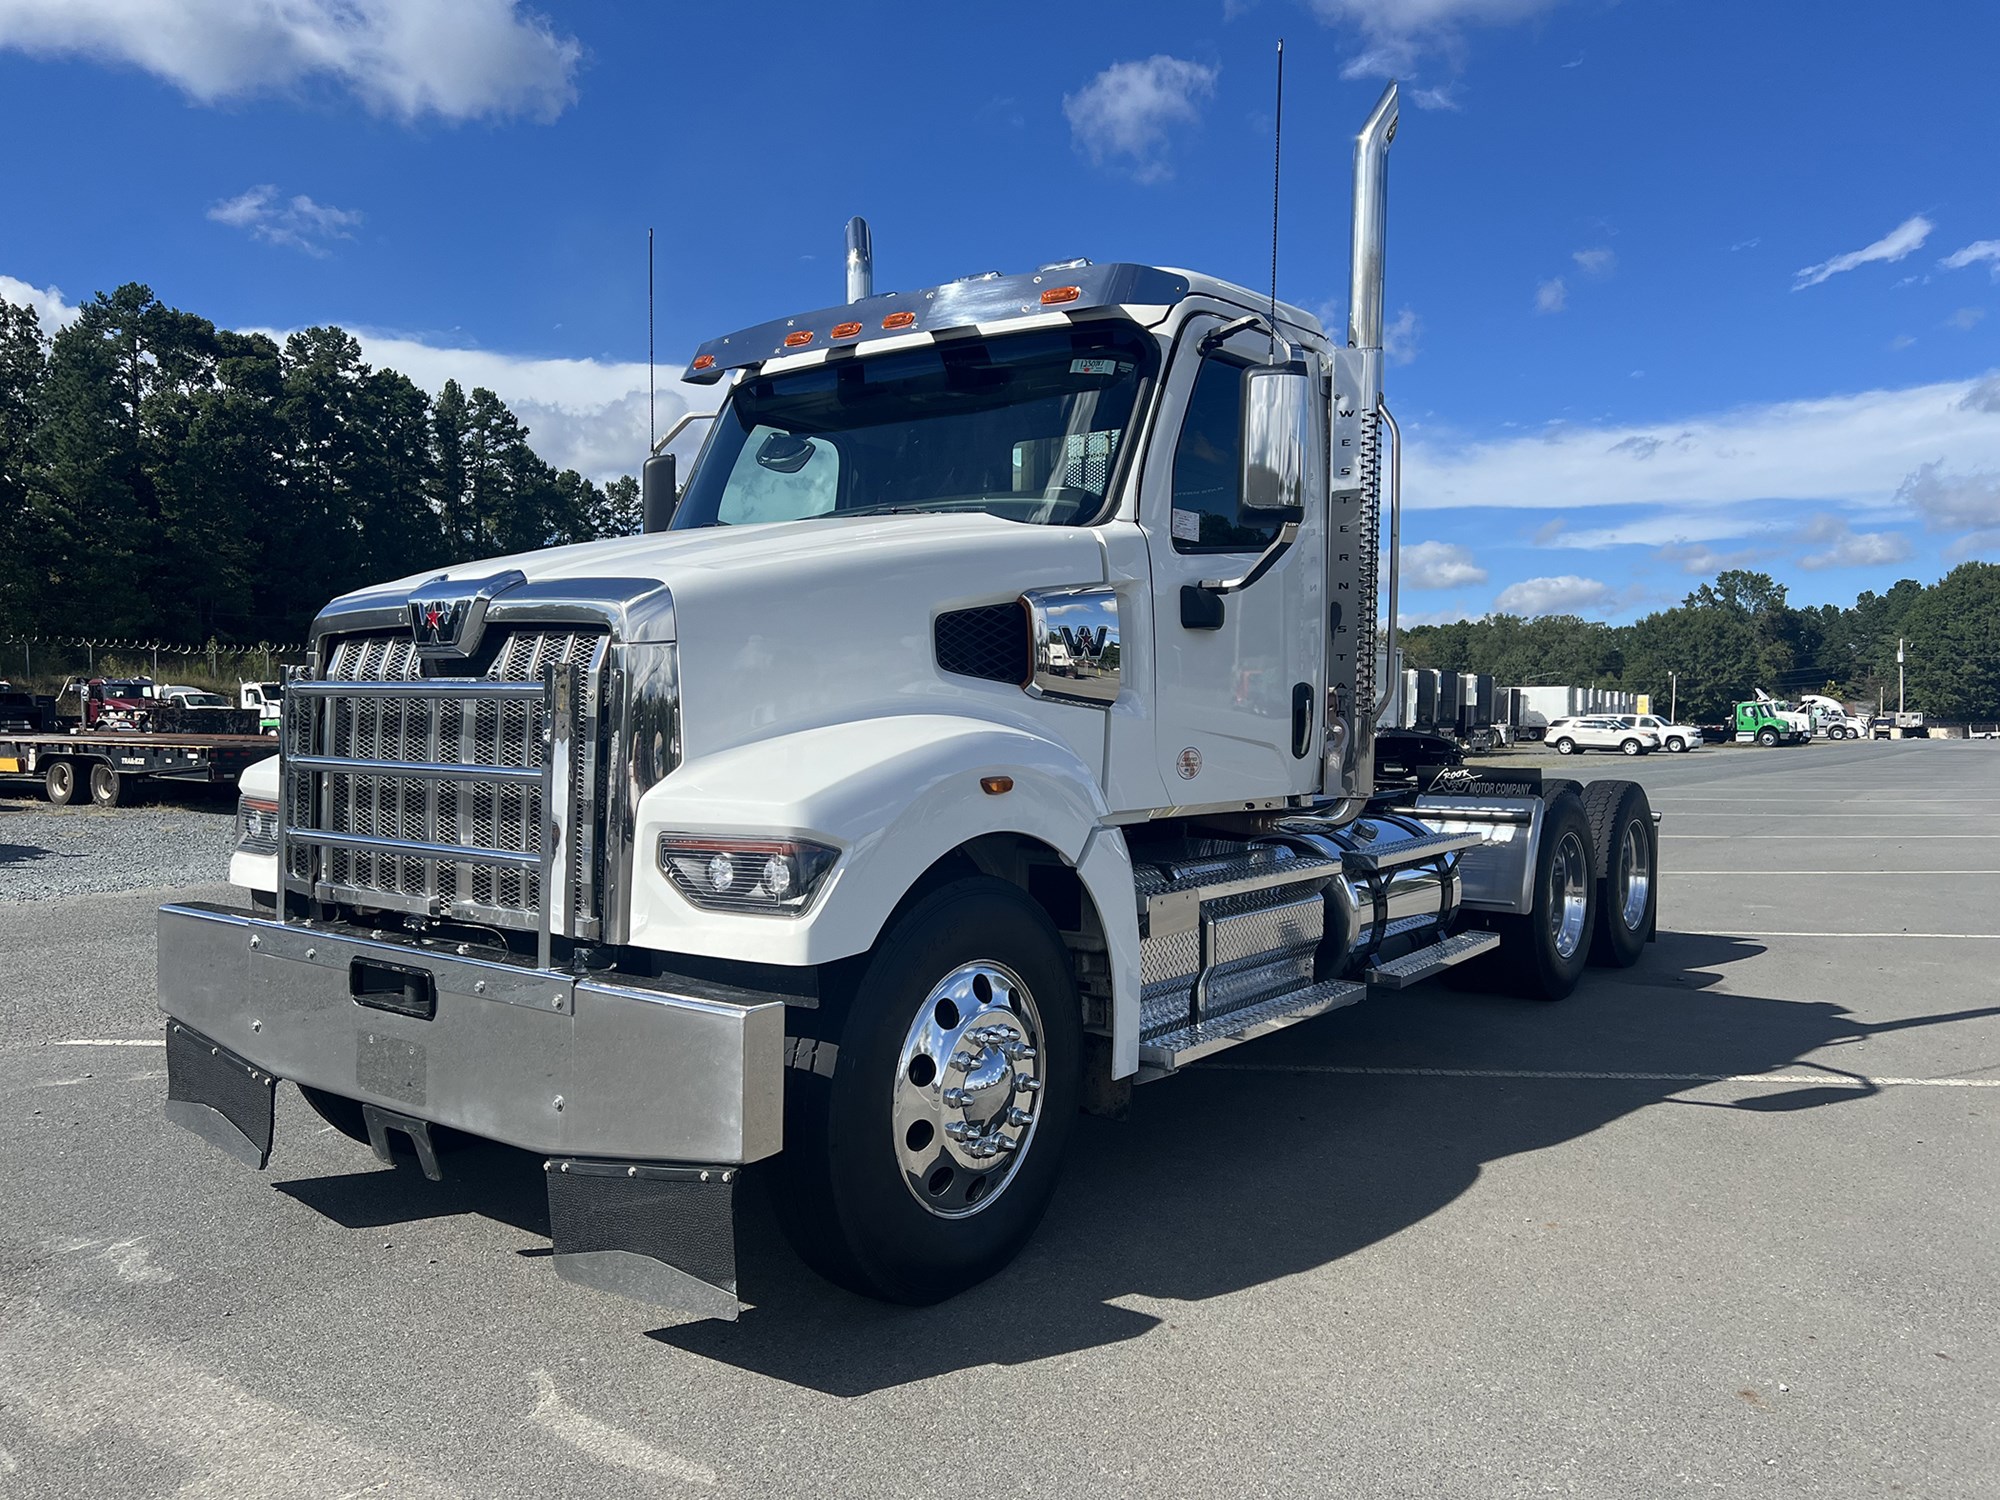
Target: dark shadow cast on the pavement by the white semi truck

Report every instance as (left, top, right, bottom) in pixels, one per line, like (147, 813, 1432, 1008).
(650, 932, 2000, 1396)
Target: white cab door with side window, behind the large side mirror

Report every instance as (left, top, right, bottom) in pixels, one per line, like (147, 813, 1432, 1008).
(1140, 320, 1326, 806)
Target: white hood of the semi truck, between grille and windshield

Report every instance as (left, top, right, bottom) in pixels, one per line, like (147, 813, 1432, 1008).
(330, 514, 1108, 758)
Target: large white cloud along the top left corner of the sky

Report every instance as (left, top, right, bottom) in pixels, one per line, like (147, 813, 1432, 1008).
(0, 0, 582, 122)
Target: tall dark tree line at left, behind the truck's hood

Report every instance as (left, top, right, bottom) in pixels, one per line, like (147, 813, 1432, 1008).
(0, 284, 638, 644)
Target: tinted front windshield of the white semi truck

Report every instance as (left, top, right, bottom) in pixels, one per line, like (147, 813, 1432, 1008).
(674, 322, 1158, 532)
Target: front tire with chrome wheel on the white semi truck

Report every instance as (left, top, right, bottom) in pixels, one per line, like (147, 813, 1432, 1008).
(774, 876, 1084, 1304)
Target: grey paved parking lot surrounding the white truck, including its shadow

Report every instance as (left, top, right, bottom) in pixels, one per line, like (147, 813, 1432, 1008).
(0, 742, 2000, 1500)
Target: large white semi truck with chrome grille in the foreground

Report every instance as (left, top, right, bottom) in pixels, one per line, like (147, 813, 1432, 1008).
(160, 88, 1658, 1318)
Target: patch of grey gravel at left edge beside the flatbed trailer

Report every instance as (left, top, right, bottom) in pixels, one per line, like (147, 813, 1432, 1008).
(0, 784, 236, 906)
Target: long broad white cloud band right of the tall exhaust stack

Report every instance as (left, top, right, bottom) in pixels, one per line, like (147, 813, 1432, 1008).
(1406, 374, 2000, 524)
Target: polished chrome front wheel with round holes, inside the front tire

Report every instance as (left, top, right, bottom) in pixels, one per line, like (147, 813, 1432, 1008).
(890, 960, 1042, 1218)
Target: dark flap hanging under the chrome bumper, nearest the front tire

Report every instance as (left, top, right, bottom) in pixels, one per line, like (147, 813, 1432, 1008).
(542, 1156, 742, 1322)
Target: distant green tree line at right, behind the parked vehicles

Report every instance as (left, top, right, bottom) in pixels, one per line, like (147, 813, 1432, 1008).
(1402, 562, 2000, 722)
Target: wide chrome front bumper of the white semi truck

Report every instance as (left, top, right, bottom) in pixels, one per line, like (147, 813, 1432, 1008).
(160, 902, 784, 1166)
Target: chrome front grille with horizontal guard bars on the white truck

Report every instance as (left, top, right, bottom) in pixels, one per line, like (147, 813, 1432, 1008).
(284, 626, 608, 938)
